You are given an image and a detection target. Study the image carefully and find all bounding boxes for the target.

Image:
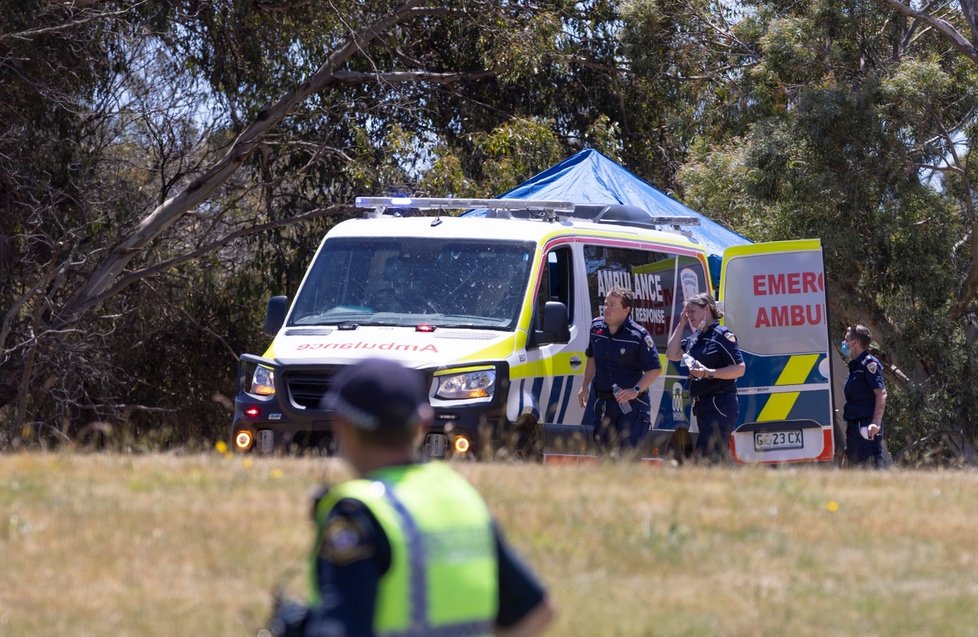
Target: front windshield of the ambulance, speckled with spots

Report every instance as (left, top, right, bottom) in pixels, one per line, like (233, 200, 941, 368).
(289, 237, 536, 330)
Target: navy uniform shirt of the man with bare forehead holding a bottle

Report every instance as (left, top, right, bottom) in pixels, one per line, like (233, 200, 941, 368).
(584, 316, 662, 393)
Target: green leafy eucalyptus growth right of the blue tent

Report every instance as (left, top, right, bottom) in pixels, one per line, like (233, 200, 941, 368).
(677, 0, 978, 461)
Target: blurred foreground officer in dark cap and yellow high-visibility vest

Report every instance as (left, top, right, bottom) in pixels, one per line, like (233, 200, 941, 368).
(269, 359, 553, 637)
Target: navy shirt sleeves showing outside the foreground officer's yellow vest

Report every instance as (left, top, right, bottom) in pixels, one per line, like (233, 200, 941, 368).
(304, 498, 545, 637)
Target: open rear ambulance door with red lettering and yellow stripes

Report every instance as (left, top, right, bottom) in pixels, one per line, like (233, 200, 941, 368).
(720, 239, 835, 463)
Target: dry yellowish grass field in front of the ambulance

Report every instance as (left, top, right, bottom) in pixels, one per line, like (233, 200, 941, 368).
(0, 453, 978, 637)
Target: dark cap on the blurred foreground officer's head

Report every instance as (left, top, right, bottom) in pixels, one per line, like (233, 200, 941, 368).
(322, 358, 430, 431)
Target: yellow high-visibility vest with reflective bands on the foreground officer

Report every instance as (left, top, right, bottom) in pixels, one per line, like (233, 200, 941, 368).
(312, 462, 499, 637)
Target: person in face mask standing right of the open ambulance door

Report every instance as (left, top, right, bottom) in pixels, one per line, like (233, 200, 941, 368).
(842, 325, 886, 468)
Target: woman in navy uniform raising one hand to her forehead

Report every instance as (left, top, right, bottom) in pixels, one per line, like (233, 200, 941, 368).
(666, 292, 747, 461)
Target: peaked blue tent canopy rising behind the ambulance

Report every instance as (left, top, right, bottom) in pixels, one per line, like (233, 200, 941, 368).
(466, 148, 751, 285)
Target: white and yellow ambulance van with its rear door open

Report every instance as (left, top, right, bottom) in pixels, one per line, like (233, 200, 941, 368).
(231, 197, 834, 463)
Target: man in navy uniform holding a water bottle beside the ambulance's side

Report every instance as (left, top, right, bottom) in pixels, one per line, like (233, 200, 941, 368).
(578, 287, 662, 451)
